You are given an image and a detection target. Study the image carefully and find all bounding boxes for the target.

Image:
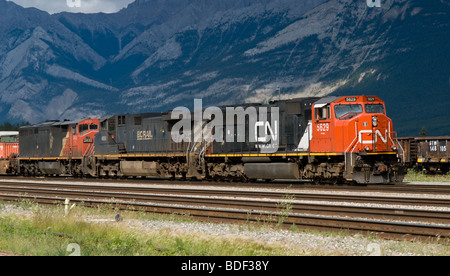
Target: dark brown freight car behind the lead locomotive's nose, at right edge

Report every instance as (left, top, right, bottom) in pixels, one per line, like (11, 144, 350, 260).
(398, 136, 450, 174)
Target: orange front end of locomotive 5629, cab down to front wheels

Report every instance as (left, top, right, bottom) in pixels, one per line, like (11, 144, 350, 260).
(310, 96, 405, 183)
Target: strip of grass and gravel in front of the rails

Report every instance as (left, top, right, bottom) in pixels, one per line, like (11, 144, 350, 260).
(0, 198, 450, 256)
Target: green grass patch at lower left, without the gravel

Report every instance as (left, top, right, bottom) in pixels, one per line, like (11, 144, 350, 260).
(0, 203, 293, 256)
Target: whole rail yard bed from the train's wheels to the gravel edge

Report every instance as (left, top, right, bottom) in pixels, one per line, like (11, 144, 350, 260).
(0, 178, 450, 242)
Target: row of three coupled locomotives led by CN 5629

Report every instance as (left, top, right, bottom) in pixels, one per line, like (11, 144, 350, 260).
(13, 96, 405, 184)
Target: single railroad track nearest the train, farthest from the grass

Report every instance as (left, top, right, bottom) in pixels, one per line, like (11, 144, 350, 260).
(0, 180, 450, 208)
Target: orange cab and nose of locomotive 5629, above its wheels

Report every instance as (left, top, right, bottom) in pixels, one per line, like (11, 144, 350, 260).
(311, 96, 398, 154)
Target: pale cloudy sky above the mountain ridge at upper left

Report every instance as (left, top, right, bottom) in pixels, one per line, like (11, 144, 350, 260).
(8, 0, 134, 13)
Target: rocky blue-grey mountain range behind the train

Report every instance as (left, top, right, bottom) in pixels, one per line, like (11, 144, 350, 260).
(0, 0, 450, 136)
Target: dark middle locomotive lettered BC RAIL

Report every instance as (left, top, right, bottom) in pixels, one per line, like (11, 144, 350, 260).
(92, 113, 185, 177)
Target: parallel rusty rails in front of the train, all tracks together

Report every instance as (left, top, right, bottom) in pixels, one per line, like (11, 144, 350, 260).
(0, 181, 450, 242)
